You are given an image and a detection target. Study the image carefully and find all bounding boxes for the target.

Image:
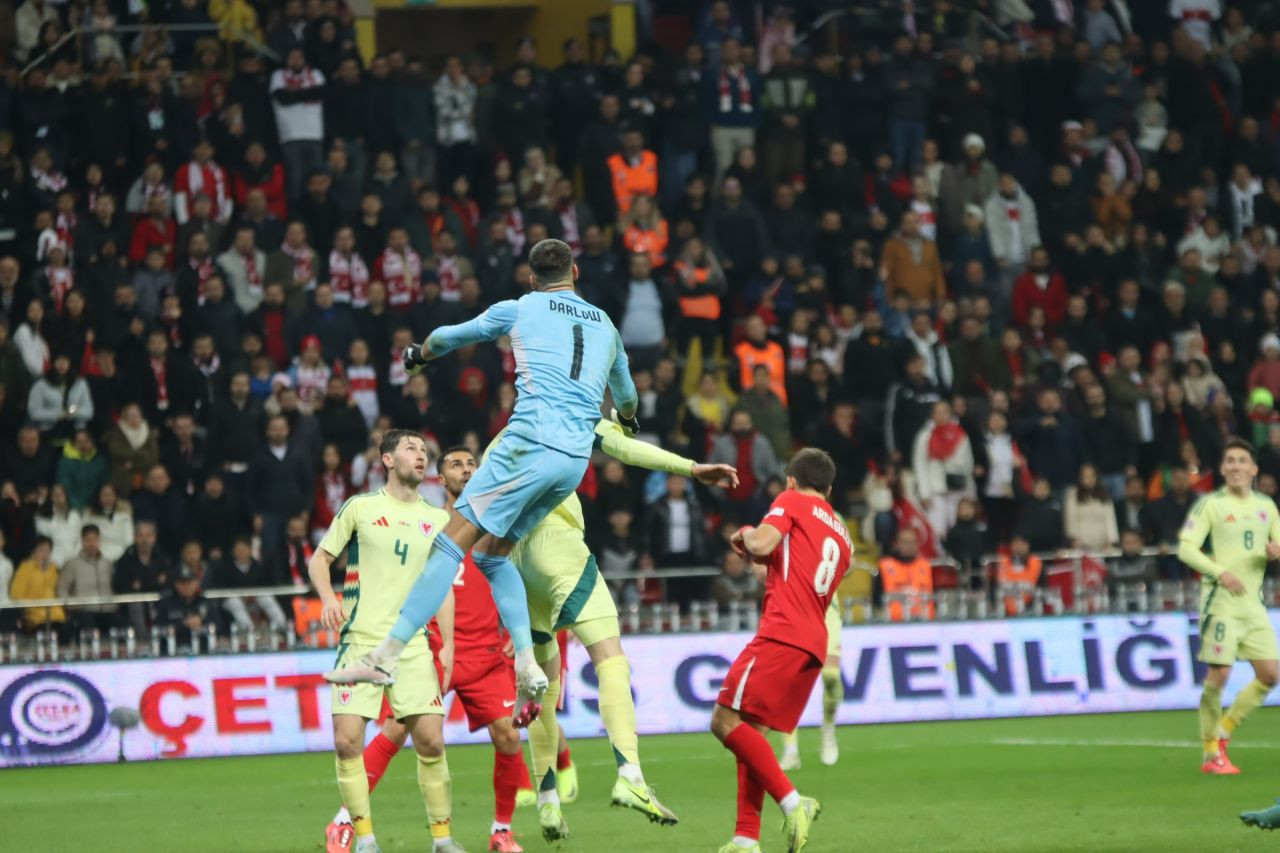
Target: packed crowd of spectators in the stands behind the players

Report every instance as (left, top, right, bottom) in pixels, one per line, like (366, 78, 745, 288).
(0, 0, 1280, 626)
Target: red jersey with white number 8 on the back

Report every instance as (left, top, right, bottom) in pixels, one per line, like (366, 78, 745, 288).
(755, 491, 854, 661)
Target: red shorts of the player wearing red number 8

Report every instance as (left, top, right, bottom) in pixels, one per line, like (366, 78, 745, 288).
(716, 637, 822, 731)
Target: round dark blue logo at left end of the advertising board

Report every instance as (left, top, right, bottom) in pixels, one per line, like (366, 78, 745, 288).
(0, 670, 106, 758)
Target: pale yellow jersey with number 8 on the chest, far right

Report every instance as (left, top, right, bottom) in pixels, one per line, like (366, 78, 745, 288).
(1180, 489, 1280, 615)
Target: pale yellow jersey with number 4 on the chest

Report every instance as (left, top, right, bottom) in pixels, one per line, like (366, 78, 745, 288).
(320, 489, 449, 647)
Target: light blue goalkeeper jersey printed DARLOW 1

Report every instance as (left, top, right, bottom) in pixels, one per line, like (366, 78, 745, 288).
(426, 291, 636, 459)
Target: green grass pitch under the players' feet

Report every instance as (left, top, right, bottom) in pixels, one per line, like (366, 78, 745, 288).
(15, 708, 1280, 853)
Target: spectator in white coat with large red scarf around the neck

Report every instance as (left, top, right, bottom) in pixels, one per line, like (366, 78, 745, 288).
(911, 401, 975, 537)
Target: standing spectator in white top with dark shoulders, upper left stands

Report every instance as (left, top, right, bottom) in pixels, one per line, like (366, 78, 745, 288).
(270, 49, 325, 200)
